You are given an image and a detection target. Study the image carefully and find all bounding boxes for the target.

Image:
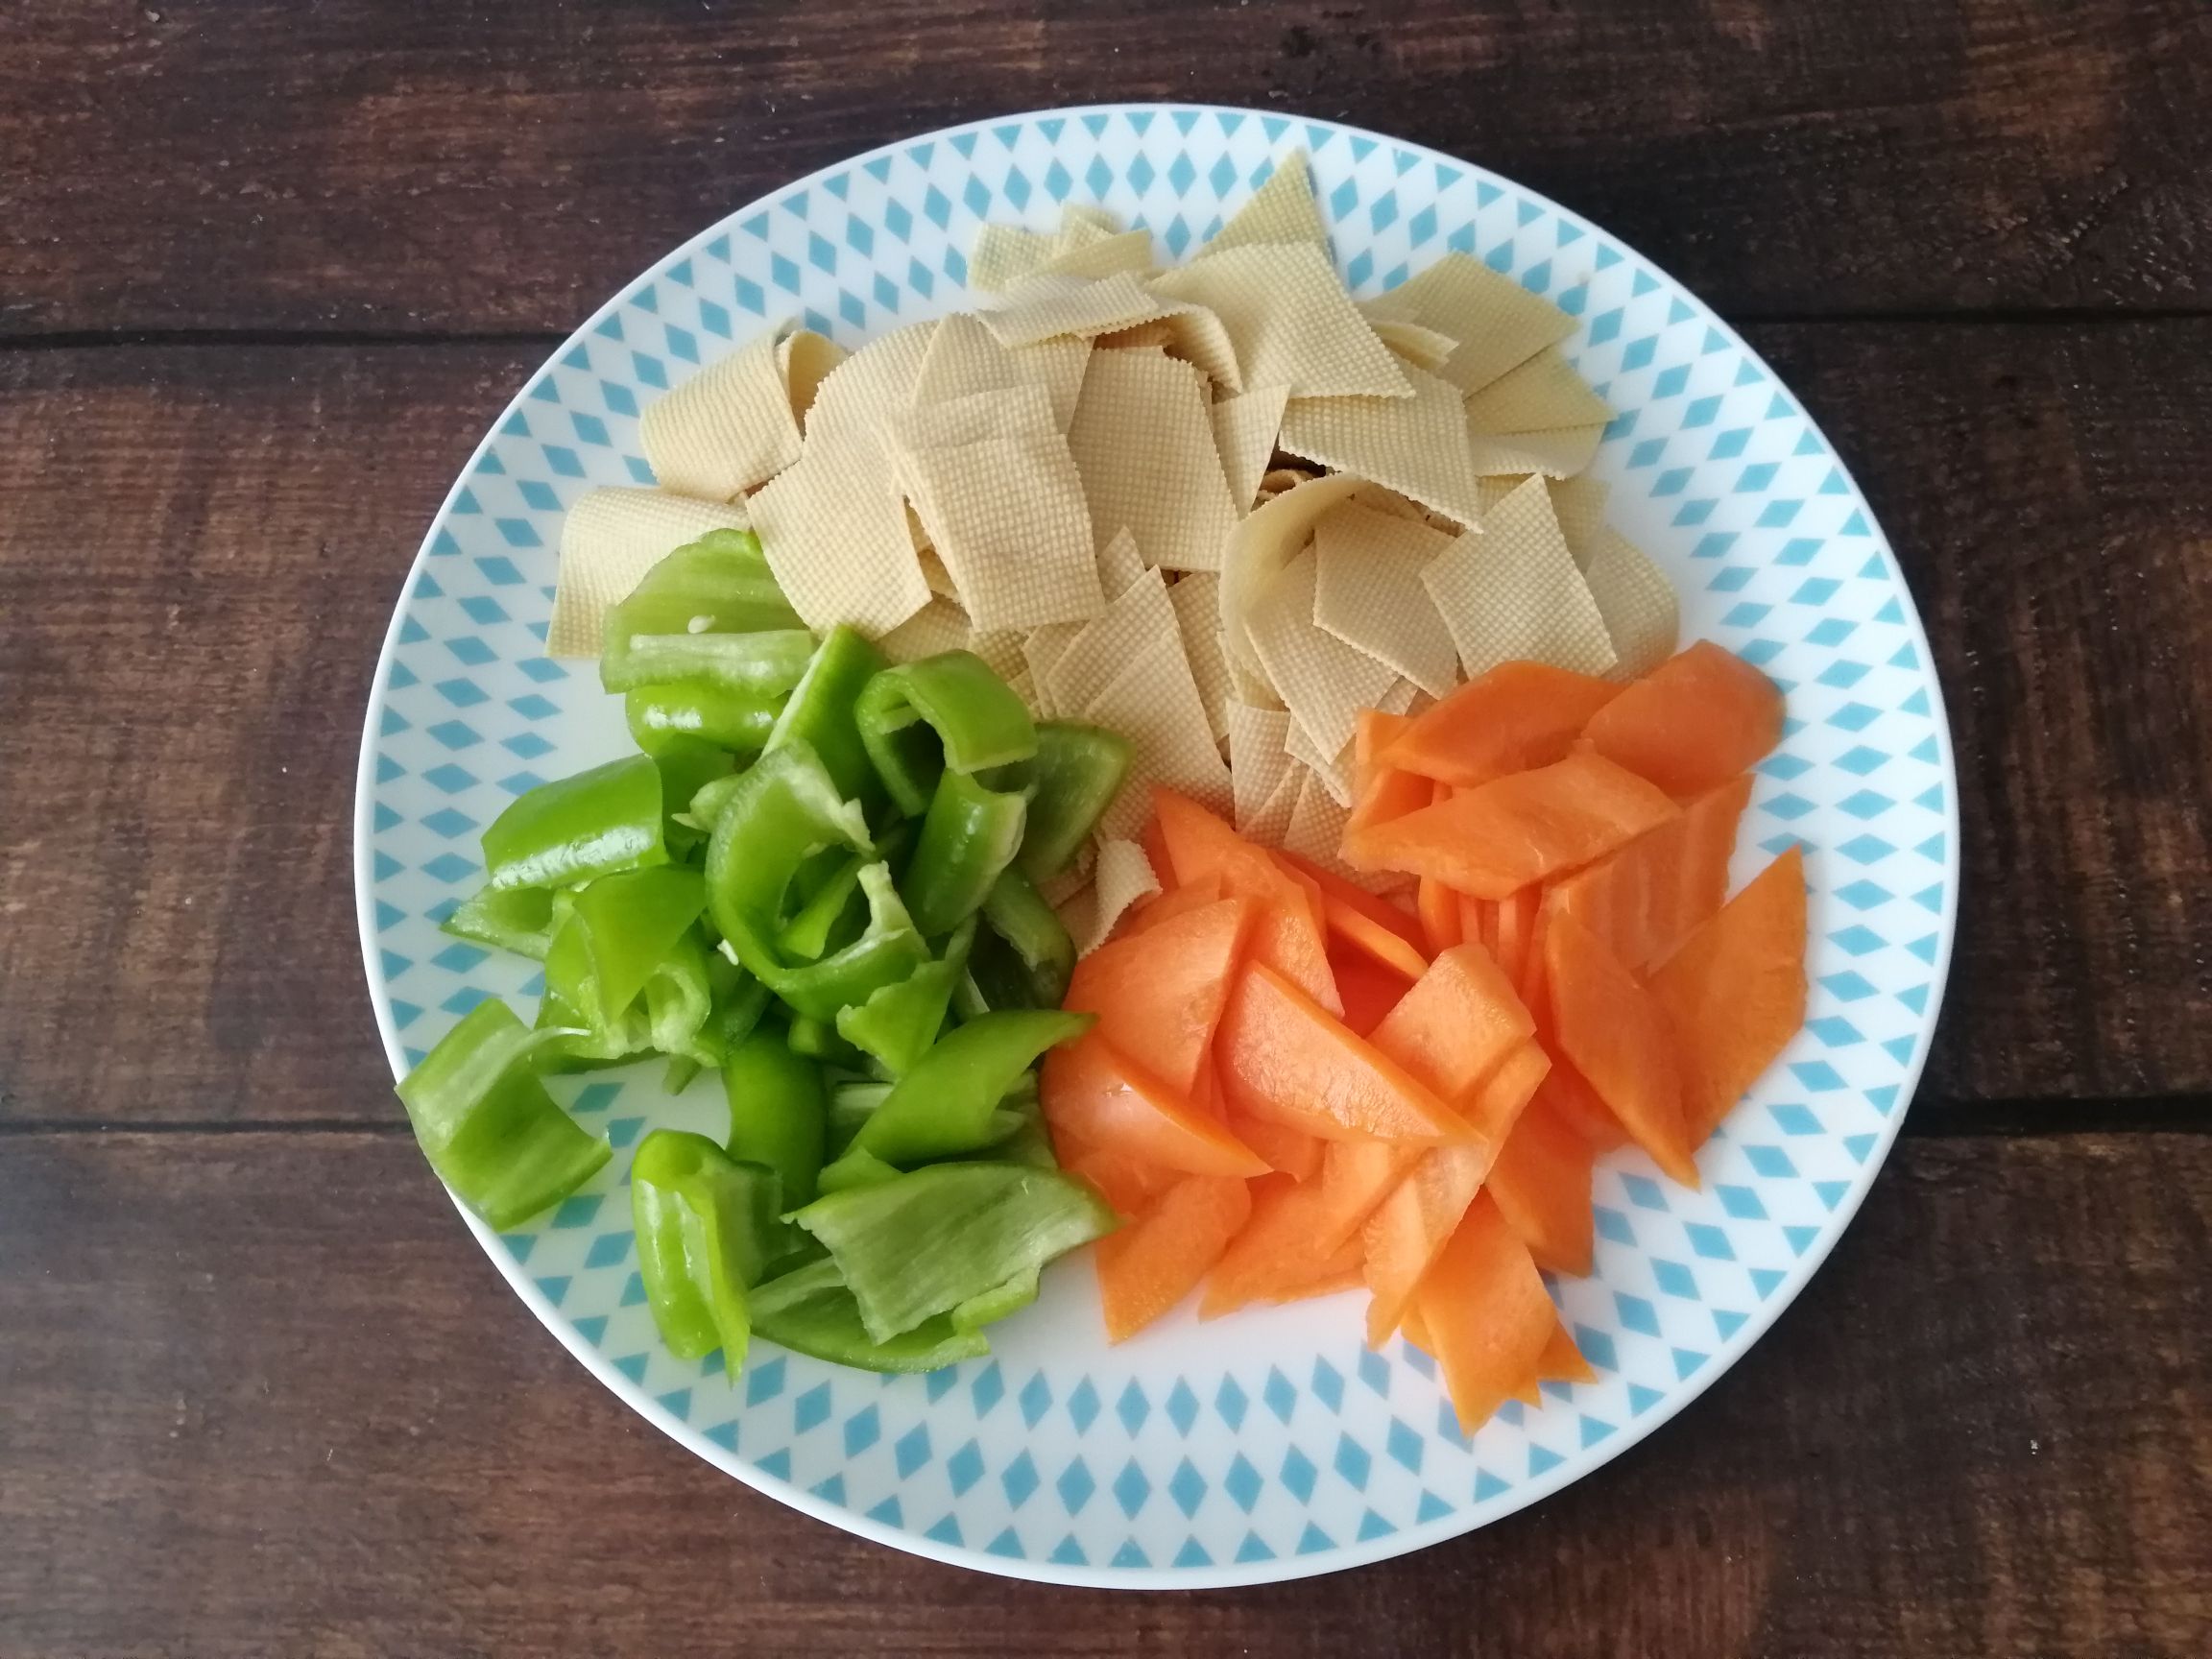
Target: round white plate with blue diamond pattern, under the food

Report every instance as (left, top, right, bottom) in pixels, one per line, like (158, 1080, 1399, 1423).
(354, 107, 1958, 1588)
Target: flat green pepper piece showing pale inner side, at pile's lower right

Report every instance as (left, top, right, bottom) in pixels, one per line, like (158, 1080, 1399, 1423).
(792, 1164, 1118, 1343)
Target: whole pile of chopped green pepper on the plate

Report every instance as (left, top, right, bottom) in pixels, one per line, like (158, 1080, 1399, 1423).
(398, 531, 1128, 1376)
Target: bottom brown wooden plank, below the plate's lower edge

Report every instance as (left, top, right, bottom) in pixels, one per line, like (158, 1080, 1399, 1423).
(0, 1133, 2212, 1659)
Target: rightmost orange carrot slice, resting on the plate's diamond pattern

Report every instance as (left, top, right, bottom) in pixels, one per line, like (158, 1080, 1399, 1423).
(1652, 847, 1805, 1145)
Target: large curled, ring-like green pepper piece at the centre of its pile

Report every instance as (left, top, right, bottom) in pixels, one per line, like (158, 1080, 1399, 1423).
(706, 741, 929, 1020)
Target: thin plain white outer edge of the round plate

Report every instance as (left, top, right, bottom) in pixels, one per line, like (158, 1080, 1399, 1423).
(351, 102, 1964, 1591)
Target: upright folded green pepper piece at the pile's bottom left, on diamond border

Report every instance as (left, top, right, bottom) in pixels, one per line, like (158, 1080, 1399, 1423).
(631, 1128, 779, 1381)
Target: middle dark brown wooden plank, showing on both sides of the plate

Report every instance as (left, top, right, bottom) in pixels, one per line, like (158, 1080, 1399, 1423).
(0, 323, 2212, 1121)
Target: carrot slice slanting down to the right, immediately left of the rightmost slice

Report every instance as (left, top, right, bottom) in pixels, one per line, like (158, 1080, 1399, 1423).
(1544, 916, 1696, 1188)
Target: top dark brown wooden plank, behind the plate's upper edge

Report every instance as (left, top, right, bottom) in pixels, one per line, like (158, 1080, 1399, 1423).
(0, 0, 2212, 332)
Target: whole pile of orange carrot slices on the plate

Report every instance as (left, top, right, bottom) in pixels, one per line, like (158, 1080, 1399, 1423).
(1061, 646, 1807, 1431)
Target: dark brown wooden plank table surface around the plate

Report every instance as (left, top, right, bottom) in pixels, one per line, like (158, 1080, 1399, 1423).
(0, 0, 2212, 1659)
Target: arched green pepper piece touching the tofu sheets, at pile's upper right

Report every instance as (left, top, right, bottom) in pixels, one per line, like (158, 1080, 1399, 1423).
(856, 650, 1038, 818)
